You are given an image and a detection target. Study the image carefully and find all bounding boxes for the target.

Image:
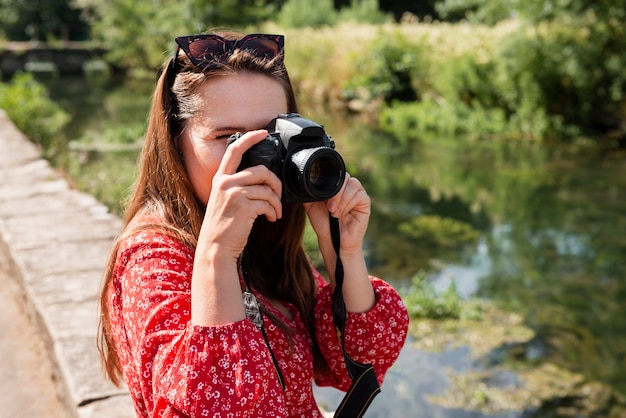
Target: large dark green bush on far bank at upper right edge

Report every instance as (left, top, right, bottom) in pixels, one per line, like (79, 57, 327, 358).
(482, 14, 626, 138)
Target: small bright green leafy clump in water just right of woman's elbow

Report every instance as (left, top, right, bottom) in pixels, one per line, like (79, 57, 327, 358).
(402, 274, 462, 320)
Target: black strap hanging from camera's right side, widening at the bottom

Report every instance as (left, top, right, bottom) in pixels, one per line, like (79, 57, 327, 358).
(330, 215, 380, 418)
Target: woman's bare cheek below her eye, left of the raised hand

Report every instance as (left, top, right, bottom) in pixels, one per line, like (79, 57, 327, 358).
(183, 140, 226, 204)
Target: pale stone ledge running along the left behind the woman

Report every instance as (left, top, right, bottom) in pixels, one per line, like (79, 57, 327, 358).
(0, 110, 135, 418)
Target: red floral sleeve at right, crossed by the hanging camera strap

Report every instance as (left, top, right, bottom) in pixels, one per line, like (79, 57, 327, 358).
(315, 277, 409, 391)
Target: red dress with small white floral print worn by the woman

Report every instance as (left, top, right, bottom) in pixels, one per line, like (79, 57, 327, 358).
(108, 230, 408, 417)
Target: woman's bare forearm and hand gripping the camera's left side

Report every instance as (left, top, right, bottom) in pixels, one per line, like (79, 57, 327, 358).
(191, 130, 282, 326)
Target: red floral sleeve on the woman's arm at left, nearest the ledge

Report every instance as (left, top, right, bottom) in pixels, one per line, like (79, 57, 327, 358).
(114, 233, 284, 417)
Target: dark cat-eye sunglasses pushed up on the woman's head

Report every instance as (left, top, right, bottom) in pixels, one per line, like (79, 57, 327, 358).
(174, 33, 285, 68)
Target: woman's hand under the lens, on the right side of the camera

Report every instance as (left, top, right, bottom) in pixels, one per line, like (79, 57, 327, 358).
(305, 173, 371, 255)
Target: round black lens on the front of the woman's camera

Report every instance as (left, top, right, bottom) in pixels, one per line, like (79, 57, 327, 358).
(287, 147, 346, 201)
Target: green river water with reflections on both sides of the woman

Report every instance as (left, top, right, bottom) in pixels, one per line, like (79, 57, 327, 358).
(42, 76, 626, 418)
